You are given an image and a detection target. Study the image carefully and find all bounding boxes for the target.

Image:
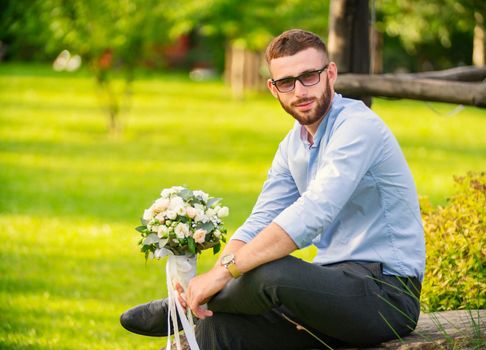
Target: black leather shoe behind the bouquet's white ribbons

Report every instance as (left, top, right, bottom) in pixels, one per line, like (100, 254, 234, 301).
(120, 299, 182, 337)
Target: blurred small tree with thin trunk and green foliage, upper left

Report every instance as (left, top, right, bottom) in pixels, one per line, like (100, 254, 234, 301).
(0, 0, 209, 132)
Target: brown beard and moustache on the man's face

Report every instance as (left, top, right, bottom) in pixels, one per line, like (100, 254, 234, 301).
(278, 79, 332, 125)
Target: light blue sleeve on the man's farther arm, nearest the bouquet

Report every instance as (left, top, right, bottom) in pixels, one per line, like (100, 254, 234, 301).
(231, 137, 299, 242)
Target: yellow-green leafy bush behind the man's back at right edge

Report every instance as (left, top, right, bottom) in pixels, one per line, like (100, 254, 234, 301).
(420, 172, 486, 311)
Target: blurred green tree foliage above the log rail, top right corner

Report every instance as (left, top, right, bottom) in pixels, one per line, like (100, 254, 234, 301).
(375, 0, 486, 70)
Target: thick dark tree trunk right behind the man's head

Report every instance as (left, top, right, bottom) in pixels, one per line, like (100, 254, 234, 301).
(328, 0, 371, 106)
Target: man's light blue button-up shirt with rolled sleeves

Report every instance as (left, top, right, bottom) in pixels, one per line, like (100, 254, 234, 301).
(231, 94, 425, 280)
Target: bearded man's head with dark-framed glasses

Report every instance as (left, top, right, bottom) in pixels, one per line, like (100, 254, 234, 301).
(265, 29, 337, 130)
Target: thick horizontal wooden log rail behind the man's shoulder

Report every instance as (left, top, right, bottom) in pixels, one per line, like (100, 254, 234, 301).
(335, 74, 486, 108)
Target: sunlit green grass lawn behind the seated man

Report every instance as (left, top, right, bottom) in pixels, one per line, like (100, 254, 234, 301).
(0, 64, 486, 349)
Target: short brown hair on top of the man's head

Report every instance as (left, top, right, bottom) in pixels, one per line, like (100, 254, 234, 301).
(265, 29, 329, 64)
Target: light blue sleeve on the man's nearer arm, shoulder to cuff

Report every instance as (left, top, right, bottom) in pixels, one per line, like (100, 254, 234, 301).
(273, 114, 383, 248)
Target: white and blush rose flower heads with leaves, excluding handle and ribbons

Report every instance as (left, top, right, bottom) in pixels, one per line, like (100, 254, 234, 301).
(136, 186, 229, 258)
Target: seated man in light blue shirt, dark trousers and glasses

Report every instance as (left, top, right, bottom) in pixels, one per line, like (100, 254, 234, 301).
(121, 29, 425, 350)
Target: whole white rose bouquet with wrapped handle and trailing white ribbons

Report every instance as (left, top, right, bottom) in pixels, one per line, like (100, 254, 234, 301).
(136, 186, 229, 350)
